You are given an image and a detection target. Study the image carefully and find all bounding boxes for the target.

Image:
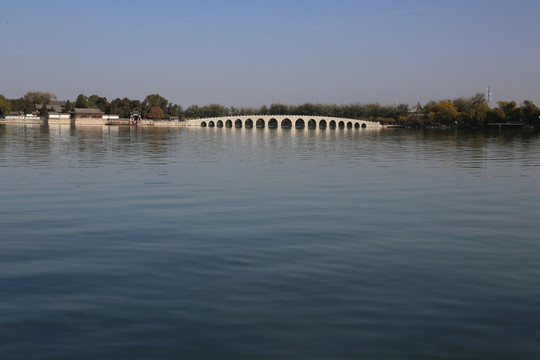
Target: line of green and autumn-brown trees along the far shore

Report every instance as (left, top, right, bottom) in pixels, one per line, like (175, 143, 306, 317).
(0, 92, 540, 127)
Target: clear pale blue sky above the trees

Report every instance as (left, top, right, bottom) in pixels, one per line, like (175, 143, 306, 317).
(0, 0, 540, 107)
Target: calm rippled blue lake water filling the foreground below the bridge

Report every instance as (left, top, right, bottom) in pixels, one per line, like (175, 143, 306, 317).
(0, 125, 540, 360)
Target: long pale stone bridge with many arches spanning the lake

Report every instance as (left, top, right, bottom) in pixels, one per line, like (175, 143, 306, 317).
(185, 115, 382, 129)
